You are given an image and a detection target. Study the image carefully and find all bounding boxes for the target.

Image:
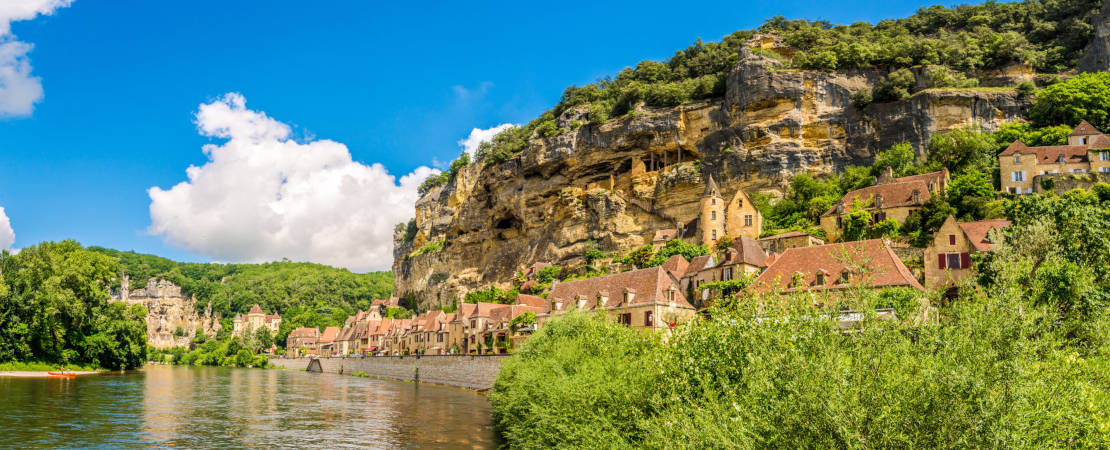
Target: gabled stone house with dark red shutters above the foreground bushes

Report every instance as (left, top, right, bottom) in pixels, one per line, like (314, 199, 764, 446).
(925, 216, 1010, 289)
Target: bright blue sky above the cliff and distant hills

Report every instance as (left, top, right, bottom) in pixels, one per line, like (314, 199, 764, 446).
(0, 0, 954, 270)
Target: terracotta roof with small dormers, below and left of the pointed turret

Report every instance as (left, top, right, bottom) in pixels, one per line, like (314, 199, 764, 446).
(547, 267, 693, 309)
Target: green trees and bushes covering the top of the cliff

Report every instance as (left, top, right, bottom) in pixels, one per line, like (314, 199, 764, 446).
(452, 0, 1099, 172)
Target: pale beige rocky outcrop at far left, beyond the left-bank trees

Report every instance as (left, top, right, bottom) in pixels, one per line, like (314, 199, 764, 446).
(113, 277, 221, 349)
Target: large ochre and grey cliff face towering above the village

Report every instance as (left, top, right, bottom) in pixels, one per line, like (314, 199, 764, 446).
(393, 50, 1029, 306)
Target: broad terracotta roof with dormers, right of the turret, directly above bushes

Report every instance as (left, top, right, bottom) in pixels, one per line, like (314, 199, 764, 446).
(753, 239, 925, 292)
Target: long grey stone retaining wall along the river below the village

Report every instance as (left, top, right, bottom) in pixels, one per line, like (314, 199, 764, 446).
(270, 354, 507, 390)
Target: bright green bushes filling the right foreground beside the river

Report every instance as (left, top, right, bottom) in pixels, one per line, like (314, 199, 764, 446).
(490, 190, 1110, 448)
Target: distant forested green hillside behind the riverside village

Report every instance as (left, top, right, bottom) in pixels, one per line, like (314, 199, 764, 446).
(89, 247, 393, 339)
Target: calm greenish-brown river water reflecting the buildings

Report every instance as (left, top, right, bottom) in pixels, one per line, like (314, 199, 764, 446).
(0, 366, 500, 449)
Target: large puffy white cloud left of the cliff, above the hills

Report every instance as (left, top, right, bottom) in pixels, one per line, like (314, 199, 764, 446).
(148, 93, 435, 271)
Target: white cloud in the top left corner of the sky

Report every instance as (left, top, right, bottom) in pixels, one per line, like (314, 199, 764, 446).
(0, 0, 73, 117)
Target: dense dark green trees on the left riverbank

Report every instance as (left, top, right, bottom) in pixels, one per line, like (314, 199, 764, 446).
(0, 241, 147, 369)
